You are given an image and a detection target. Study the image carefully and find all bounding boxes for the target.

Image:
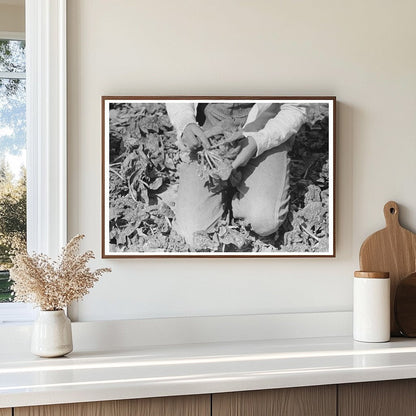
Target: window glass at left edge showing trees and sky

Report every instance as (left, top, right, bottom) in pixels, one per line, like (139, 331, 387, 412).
(0, 40, 26, 303)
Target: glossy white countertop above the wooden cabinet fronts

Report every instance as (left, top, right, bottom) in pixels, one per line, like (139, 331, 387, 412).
(0, 337, 416, 408)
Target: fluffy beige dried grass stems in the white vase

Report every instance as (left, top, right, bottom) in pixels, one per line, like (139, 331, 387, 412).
(10, 235, 111, 311)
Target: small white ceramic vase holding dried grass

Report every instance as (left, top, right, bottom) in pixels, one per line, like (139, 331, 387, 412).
(31, 310, 72, 358)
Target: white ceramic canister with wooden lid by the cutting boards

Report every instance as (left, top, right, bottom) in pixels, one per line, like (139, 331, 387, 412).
(353, 271, 390, 342)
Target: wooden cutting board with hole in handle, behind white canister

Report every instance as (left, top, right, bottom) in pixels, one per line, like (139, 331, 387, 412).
(360, 201, 416, 336)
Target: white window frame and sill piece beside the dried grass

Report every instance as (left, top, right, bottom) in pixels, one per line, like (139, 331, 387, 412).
(0, 0, 67, 322)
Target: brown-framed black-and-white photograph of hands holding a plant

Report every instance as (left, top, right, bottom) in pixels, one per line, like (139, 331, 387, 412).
(102, 97, 336, 258)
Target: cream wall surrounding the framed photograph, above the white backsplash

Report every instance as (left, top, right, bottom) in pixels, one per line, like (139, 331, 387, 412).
(68, 0, 416, 320)
